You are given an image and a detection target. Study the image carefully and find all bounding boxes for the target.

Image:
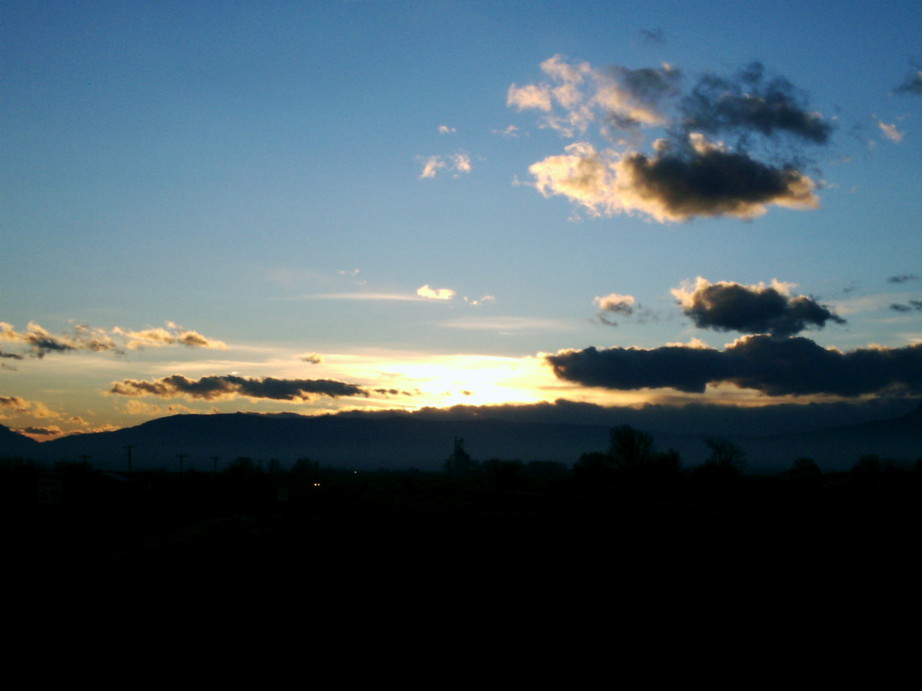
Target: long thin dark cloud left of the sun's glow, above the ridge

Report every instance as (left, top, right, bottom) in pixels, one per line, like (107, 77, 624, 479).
(109, 374, 368, 401)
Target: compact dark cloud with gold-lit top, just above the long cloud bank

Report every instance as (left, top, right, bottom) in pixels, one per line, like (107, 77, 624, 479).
(672, 277, 845, 336)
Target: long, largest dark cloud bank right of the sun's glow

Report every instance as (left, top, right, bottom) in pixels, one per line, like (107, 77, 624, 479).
(547, 335, 922, 396)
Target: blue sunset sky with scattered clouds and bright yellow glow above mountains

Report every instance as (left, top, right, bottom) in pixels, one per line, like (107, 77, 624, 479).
(0, 0, 922, 440)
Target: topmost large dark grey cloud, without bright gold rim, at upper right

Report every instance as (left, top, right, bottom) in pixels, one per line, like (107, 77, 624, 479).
(679, 62, 832, 145)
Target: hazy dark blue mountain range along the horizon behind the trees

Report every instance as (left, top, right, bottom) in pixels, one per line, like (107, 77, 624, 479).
(0, 408, 922, 471)
